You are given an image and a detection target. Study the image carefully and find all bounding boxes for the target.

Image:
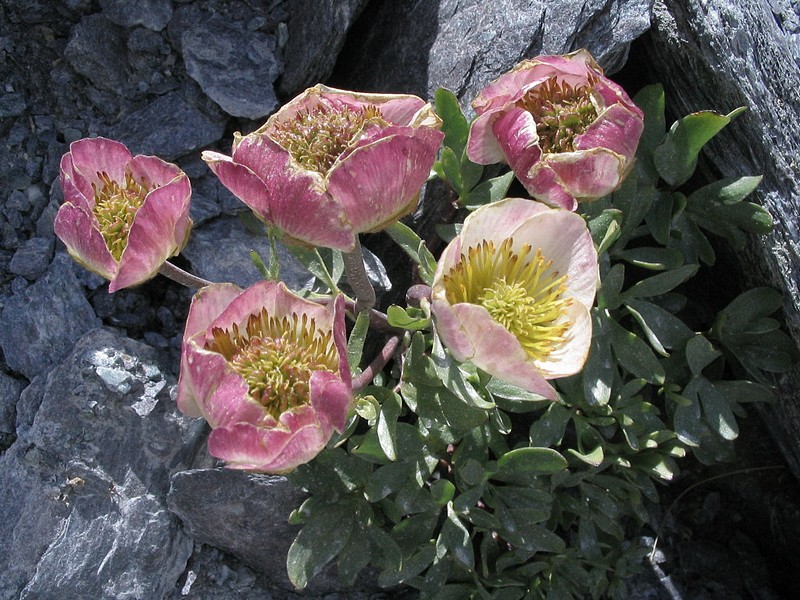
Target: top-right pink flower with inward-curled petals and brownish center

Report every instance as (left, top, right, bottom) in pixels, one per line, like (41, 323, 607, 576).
(467, 50, 643, 210)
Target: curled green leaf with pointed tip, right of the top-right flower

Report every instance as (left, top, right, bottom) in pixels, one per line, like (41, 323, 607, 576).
(653, 107, 745, 186)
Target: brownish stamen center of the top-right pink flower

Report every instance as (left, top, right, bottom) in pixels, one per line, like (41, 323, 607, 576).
(517, 75, 597, 153)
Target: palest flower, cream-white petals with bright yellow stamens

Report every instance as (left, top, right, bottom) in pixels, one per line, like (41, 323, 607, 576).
(431, 198, 598, 399)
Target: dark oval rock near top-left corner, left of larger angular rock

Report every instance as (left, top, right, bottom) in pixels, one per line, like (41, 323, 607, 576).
(64, 14, 129, 93)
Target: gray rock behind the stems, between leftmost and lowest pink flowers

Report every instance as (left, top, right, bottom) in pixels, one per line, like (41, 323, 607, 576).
(182, 215, 311, 290)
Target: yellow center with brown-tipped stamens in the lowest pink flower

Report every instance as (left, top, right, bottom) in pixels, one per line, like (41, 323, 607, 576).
(206, 309, 339, 420)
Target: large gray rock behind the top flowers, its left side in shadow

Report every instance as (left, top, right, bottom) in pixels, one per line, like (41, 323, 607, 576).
(332, 0, 653, 102)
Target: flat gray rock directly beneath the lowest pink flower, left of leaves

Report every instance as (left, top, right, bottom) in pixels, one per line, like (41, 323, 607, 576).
(167, 469, 304, 589)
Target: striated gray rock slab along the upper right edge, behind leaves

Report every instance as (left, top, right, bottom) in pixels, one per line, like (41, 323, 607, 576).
(644, 0, 800, 476)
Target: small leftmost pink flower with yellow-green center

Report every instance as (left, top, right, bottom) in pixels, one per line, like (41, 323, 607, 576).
(54, 137, 192, 292)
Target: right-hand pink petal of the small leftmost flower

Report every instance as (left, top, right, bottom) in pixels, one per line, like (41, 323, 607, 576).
(108, 174, 192, 292)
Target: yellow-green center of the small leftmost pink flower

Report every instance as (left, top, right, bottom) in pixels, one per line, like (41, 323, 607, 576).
(92, 173, 152, 262)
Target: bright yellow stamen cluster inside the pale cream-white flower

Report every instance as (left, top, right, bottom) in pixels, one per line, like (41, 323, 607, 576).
(443, 238, 571, 360)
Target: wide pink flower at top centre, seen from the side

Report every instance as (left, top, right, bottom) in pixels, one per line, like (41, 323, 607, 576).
(203, 85, 444, 252)
